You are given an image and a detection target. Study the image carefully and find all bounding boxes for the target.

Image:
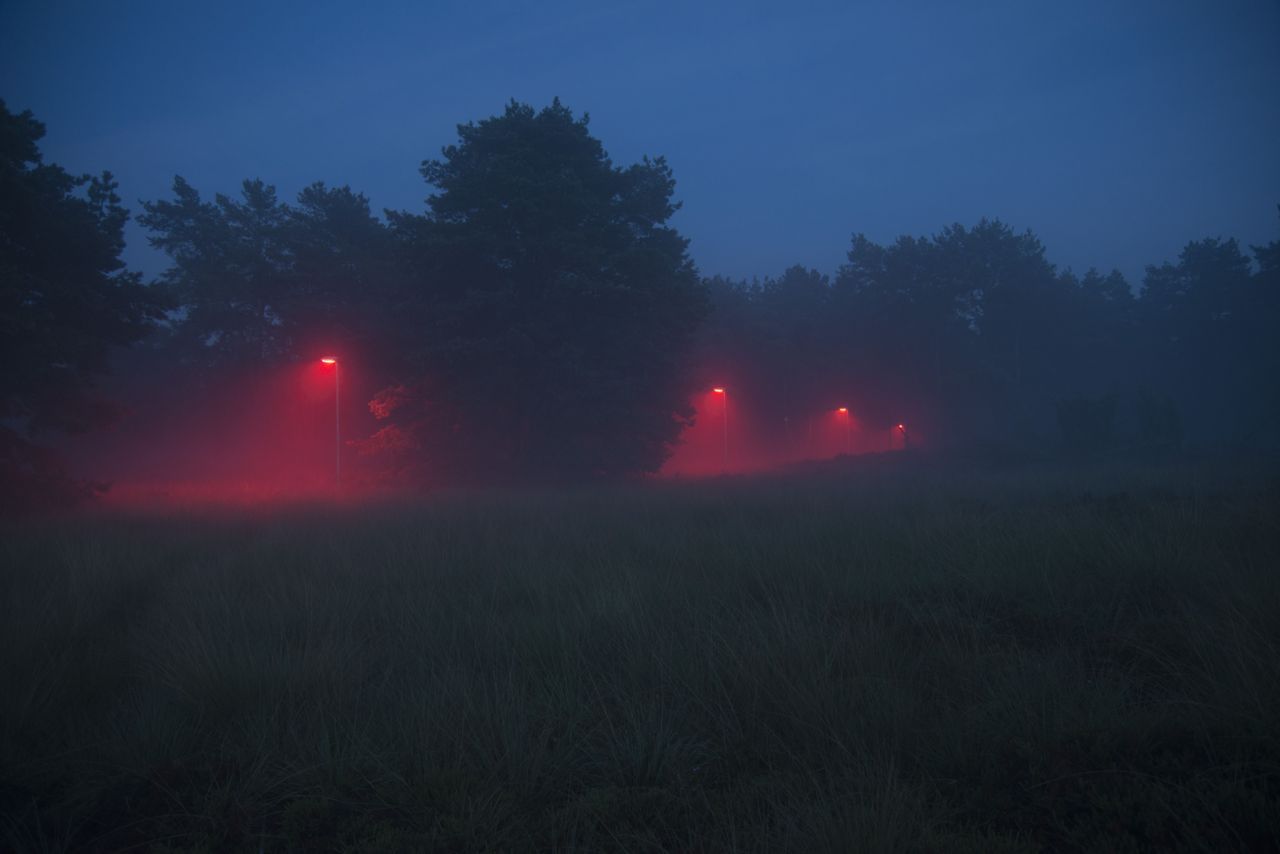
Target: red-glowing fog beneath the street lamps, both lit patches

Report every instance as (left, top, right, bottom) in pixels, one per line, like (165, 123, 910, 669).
(58, 371, 911, 506)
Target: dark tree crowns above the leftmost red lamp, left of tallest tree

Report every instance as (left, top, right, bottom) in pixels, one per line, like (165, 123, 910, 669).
(140, 177, 394, 371)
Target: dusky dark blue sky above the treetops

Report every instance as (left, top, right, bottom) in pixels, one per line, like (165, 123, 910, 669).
(0, 0, 1280, 284)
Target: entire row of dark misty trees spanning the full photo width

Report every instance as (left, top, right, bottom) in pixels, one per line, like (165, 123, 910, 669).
(0, 95, 1280, 503)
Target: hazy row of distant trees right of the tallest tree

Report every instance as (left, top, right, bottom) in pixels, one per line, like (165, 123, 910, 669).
(703, 220, 1280, 453)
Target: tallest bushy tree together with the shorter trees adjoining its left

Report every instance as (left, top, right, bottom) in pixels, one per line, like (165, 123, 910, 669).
(132, 101, 707, 483)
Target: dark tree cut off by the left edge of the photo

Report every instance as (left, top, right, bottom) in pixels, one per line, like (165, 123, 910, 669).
(0, 101, 164, 510)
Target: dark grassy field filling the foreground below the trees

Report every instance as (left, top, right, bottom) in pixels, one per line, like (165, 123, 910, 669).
(0, 461, 1280, 853)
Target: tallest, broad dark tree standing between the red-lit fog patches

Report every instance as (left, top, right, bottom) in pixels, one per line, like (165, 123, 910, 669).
(374, 101, 707, 476)
